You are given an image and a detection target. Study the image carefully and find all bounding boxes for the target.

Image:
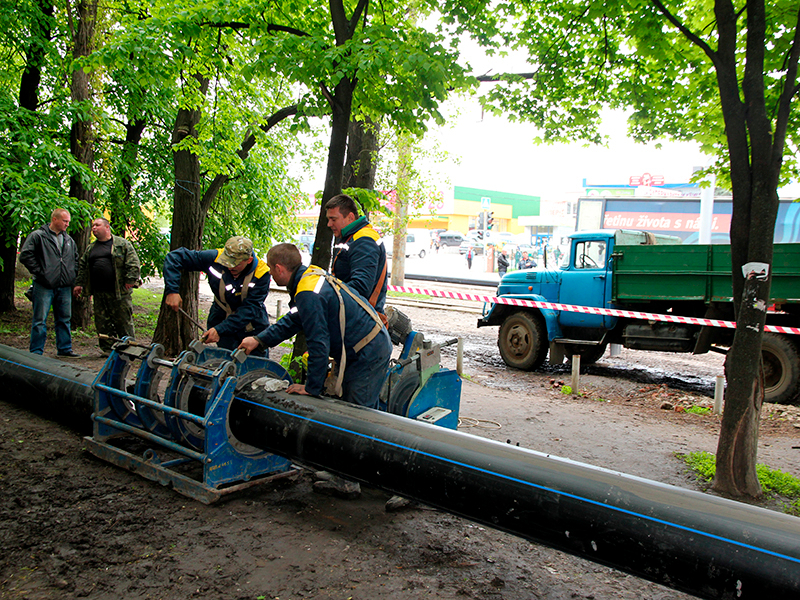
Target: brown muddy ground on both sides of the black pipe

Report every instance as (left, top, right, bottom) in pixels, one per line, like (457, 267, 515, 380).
(0, 282, 800, 600)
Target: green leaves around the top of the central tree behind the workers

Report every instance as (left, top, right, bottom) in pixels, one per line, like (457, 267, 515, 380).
(247, 1, 472, 135)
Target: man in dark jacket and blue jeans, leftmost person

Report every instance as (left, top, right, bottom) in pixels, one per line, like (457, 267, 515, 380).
(19, 208, 78, 358)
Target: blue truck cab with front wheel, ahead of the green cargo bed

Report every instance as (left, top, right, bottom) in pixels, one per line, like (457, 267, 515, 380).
(478, 229, 680, 370)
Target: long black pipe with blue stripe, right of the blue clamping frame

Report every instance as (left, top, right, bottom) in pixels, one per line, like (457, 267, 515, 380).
(229, 391, 800, 600)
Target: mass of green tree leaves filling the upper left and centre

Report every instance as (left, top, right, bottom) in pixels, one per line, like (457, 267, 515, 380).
(0, 0, 474, 302)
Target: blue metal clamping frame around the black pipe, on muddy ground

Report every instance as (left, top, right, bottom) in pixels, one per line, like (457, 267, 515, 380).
(86, 339, 298, 504)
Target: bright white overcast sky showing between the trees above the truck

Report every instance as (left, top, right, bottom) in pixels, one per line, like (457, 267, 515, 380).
(296, 38, 800, 202)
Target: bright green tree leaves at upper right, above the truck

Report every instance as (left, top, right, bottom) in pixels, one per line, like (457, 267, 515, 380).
(440, 0, 800, 185)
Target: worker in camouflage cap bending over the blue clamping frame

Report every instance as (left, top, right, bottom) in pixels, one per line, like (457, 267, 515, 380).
(164, 235, 270, 355)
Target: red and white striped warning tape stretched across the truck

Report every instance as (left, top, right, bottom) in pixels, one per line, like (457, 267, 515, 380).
(389, 285, 800, 334)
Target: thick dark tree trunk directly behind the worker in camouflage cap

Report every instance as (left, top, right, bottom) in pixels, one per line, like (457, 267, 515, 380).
(153, 78, 208, 356)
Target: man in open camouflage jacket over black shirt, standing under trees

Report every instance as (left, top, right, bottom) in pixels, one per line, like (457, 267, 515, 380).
(72, 217, 140, 356)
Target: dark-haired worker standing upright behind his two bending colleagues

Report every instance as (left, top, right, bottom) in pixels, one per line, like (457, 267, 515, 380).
(325, 194, 387, 314)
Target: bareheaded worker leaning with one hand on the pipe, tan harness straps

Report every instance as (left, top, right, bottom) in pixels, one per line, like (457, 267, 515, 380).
(240, 244, 392, 408)
